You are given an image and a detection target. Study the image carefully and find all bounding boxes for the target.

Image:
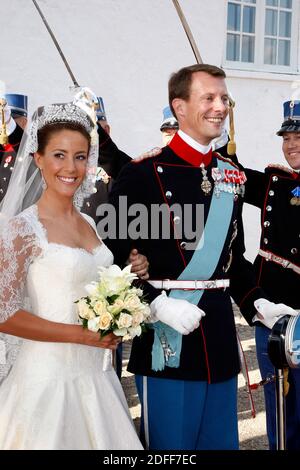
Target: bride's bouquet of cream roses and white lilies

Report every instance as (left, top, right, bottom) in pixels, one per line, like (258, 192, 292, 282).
(76, 264, 150, 340)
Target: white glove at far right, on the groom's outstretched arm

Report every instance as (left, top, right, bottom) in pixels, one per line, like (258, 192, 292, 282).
(253, 299, 297, 329)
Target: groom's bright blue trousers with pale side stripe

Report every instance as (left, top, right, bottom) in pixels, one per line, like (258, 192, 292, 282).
(136, 376, 238, 450)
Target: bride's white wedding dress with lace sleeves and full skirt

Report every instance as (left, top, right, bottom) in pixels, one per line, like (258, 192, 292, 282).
(0, 206, 142, 450)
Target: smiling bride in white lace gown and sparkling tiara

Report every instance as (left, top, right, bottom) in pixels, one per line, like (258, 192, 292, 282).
(0, 103, 142, 450)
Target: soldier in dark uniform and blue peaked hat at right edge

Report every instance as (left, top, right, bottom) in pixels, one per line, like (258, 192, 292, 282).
(241, 101, 300, 450)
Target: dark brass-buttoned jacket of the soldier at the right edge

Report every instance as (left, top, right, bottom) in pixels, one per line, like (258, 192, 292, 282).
(241, 166, 300, 312)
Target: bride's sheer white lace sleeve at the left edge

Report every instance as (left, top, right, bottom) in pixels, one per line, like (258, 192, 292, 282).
(0, 214, 42, 322)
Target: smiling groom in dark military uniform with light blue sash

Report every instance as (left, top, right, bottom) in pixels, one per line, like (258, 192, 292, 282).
(107, 64, 296, 450)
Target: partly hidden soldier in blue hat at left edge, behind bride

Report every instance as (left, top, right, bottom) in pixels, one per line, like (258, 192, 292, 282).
(0, 94, 27, 202)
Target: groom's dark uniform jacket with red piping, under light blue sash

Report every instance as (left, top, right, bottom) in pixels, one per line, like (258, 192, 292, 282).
(106, 138, 263, 382)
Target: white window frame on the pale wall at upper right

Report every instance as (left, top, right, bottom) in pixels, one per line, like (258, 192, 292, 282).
(223, 0, 300, 74)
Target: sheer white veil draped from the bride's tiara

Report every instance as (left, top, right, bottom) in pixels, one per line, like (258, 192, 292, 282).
(0, 92, 98, 233)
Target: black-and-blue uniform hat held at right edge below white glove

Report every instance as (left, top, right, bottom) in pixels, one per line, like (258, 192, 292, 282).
(268, 315, 300, 369)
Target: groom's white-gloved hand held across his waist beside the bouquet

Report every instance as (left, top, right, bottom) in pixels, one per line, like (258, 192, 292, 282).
(150, 292, 205, 335)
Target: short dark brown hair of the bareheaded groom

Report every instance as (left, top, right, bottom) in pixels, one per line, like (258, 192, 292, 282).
(169, 64, 226, 116)
